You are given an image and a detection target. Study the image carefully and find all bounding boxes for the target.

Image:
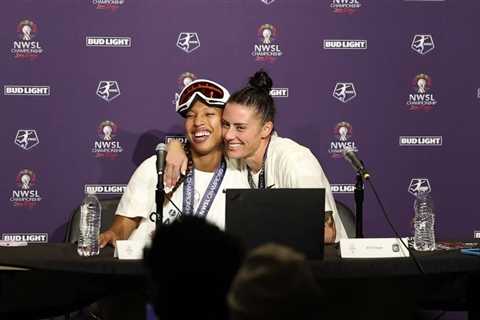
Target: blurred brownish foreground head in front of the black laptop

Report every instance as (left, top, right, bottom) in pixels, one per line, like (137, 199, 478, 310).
(228, 244, 323, 320)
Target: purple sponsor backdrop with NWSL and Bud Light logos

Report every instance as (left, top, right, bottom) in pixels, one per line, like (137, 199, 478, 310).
(0, 0, 480, 242)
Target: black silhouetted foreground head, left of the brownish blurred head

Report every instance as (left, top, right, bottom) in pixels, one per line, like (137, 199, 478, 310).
(145, 216, 244, 320)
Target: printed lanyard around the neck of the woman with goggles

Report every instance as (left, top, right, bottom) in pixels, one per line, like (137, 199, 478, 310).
(182, 159, 227, 218)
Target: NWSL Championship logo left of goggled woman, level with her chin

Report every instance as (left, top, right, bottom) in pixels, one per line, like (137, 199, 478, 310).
(92, 120, 123, 160)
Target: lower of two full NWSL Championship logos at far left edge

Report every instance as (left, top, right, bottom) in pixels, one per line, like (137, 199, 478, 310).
(10, 169, 42, 208)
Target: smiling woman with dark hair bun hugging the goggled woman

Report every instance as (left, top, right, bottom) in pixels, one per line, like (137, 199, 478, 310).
(167, 71, 347, 243)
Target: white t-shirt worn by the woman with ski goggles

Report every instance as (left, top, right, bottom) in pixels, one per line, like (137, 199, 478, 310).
(116, 156, 249, 245)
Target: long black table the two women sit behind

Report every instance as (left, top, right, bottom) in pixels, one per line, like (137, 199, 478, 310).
(0, 243, 480, 319)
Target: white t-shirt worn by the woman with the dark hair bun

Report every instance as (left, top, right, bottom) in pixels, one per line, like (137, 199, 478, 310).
(254, 134, 348, 241)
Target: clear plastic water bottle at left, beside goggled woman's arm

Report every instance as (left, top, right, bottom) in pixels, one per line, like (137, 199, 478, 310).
(77, 193, 102, 257)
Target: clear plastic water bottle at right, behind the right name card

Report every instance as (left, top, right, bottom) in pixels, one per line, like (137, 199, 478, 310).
(413, 192, 435, 251)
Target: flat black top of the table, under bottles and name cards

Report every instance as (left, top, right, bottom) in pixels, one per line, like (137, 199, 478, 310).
(0, 243, 480, 277)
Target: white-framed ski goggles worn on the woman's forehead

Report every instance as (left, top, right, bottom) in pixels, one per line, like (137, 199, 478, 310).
(176, 79, 230, 117)
